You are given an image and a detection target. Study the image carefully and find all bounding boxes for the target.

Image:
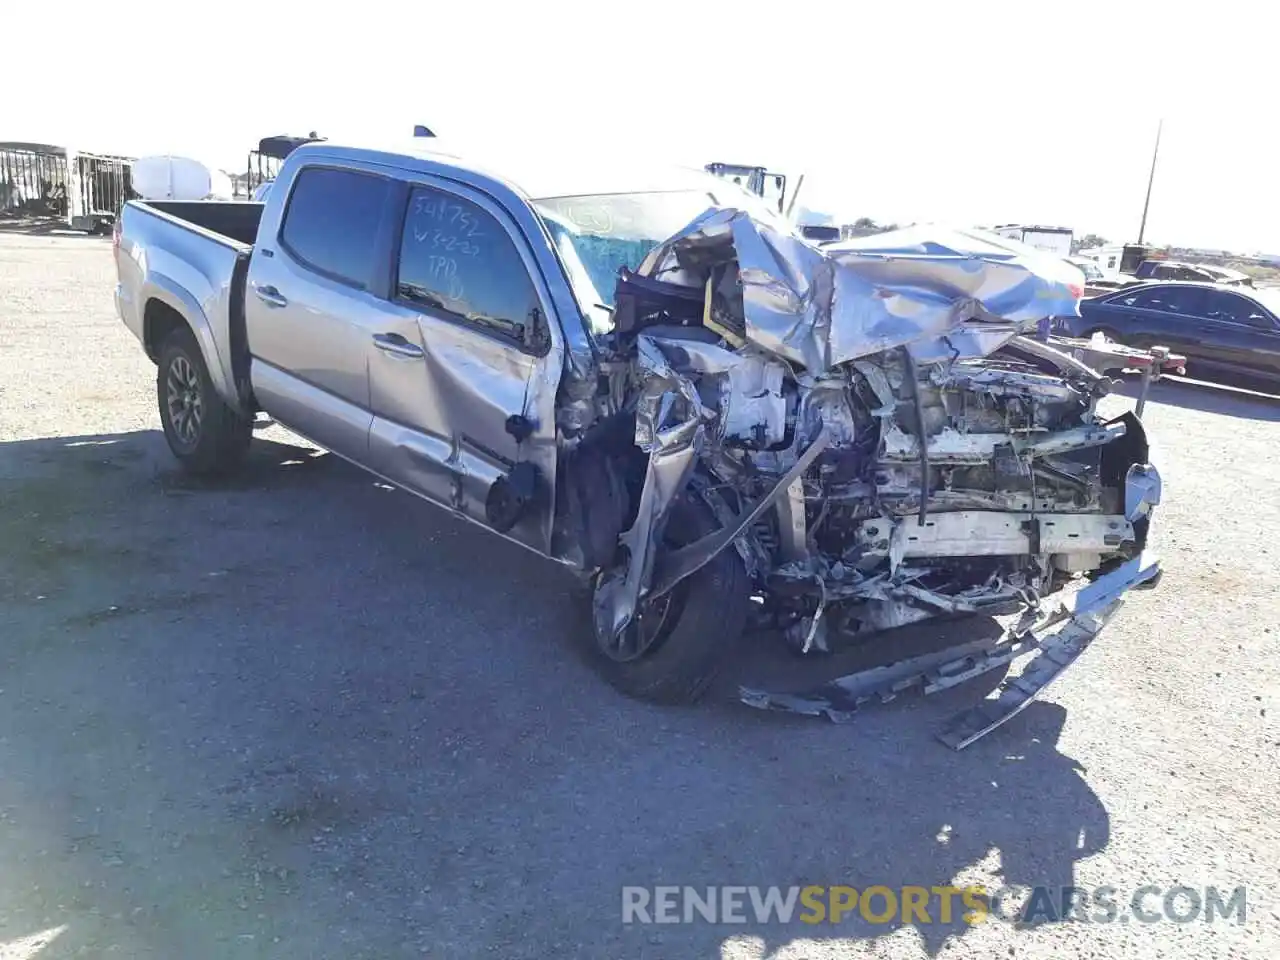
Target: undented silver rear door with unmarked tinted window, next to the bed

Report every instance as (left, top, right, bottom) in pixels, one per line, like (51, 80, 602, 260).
(244, 163, 397, 463)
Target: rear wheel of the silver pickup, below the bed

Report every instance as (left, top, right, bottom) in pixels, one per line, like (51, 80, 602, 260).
(156, 326, 253, 476)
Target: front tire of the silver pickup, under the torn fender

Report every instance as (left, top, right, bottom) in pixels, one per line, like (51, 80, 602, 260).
(581, 493, 750, 704)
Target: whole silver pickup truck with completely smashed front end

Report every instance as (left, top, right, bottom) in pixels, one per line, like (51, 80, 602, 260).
(115, 141, 1161, 746)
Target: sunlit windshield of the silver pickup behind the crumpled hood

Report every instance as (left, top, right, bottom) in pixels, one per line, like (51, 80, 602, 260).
(532, 183, 777, 333)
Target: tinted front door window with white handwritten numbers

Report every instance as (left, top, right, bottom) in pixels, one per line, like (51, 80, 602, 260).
(396, 187, 539, 344)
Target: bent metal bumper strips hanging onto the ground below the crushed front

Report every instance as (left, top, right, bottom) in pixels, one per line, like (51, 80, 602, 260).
(739, 552, 1160, 750)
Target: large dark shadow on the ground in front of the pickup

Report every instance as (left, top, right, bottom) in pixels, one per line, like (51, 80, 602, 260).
(0, 431, 1108, 960)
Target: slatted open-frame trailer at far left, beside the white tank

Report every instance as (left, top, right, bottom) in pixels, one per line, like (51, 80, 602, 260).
(0, 142, 134, 233)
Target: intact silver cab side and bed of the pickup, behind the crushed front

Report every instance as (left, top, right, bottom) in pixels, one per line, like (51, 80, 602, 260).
(116, 146, 590, 550)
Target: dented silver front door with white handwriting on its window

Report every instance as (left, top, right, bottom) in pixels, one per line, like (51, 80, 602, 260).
(360, 181, 562, 550)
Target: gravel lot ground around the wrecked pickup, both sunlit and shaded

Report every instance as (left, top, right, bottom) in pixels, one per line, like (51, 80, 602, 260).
(0, 229, 1280, 960)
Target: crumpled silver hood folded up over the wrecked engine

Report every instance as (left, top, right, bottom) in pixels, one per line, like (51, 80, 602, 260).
(637, 207, 1083, 374)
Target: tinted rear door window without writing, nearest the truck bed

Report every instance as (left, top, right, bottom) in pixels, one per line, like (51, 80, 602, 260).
(280, 166, 390, 291)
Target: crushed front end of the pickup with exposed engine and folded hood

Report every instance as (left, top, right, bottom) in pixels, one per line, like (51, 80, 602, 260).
(565, 209, 1160, 701)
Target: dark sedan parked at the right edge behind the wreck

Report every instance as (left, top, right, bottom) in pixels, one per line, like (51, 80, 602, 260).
(1055, 283, 1280, 392)
